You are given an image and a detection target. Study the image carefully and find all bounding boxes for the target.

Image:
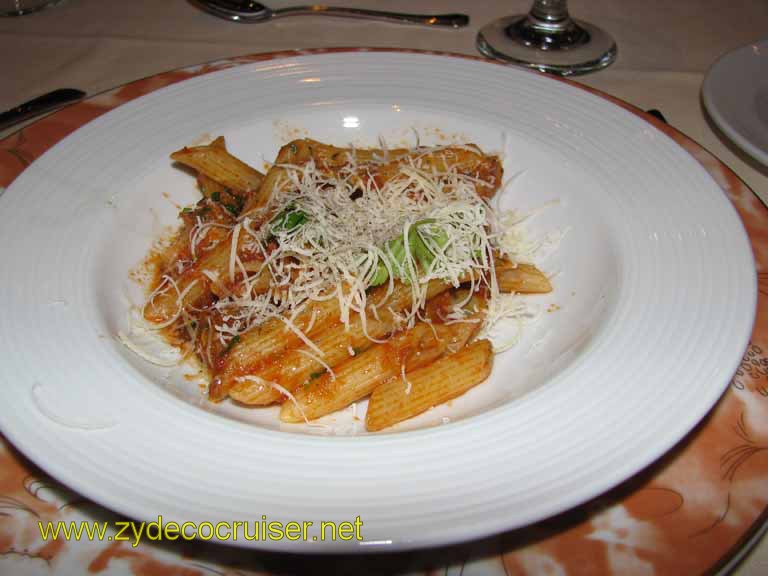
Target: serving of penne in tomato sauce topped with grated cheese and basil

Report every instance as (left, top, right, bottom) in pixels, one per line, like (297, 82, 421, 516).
(135, 137, 552, 430)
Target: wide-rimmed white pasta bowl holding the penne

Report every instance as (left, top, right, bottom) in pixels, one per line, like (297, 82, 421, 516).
(0, 51, 756, 552)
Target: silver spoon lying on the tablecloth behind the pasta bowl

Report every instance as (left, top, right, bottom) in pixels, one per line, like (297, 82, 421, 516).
(190, 0, 469, 28)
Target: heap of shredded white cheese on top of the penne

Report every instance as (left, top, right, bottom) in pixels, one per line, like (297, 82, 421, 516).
(200, 148, 510, 346)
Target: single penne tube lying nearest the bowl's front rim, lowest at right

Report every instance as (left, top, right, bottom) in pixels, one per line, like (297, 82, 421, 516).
(365, 340, 493, 432)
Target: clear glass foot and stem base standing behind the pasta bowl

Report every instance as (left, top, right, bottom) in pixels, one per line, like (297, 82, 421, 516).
(477, 0, 616, 76)
